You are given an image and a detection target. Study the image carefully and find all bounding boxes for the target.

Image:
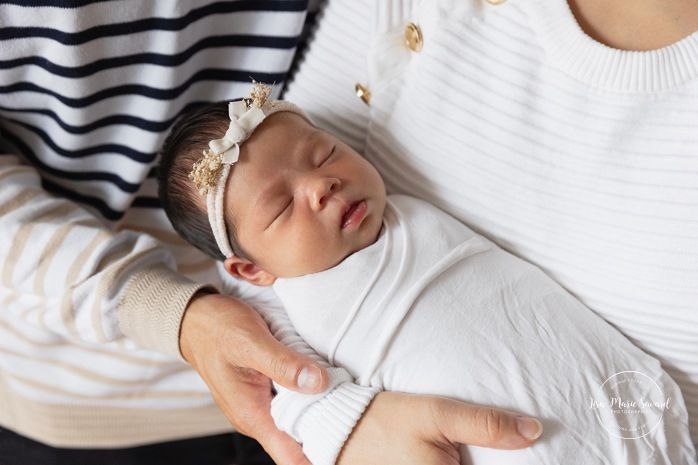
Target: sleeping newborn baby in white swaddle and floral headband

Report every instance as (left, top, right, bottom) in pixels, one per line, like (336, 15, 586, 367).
(161, 84, 695, 465)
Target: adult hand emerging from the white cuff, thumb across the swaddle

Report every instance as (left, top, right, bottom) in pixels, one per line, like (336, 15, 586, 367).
(337, 392, 542, 465)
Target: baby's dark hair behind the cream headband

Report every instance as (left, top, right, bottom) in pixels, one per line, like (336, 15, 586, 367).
(158, 101, 249, 260)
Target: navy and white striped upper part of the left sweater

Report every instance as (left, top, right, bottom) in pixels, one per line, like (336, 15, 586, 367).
(0, 0, 307, 221)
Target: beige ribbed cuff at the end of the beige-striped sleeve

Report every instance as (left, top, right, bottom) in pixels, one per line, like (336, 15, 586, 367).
(119, 266, 207, 361)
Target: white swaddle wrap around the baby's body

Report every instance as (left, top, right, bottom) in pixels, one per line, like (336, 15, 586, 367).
(274, 196, 695, 465)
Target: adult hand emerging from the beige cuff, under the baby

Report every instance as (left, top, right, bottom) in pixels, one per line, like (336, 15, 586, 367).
(180, 292, 328, 465)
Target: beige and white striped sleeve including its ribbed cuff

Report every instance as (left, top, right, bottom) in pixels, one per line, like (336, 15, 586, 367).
(0, 155, 211, 357)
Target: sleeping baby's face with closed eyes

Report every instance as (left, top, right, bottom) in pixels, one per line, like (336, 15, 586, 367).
(226, 112, 386, 277)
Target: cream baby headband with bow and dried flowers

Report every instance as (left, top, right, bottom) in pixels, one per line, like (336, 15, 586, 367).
(189, 84, 312, 258)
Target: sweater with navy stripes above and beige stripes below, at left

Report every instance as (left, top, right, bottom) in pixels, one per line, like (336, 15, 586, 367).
(0, 0, 374, 456)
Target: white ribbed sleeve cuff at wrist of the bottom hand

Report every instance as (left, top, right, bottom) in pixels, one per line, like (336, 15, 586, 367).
(298, 383, 379, 465)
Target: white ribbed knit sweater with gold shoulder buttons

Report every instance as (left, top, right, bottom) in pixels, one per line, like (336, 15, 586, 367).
(286, 0, 698, 442)
